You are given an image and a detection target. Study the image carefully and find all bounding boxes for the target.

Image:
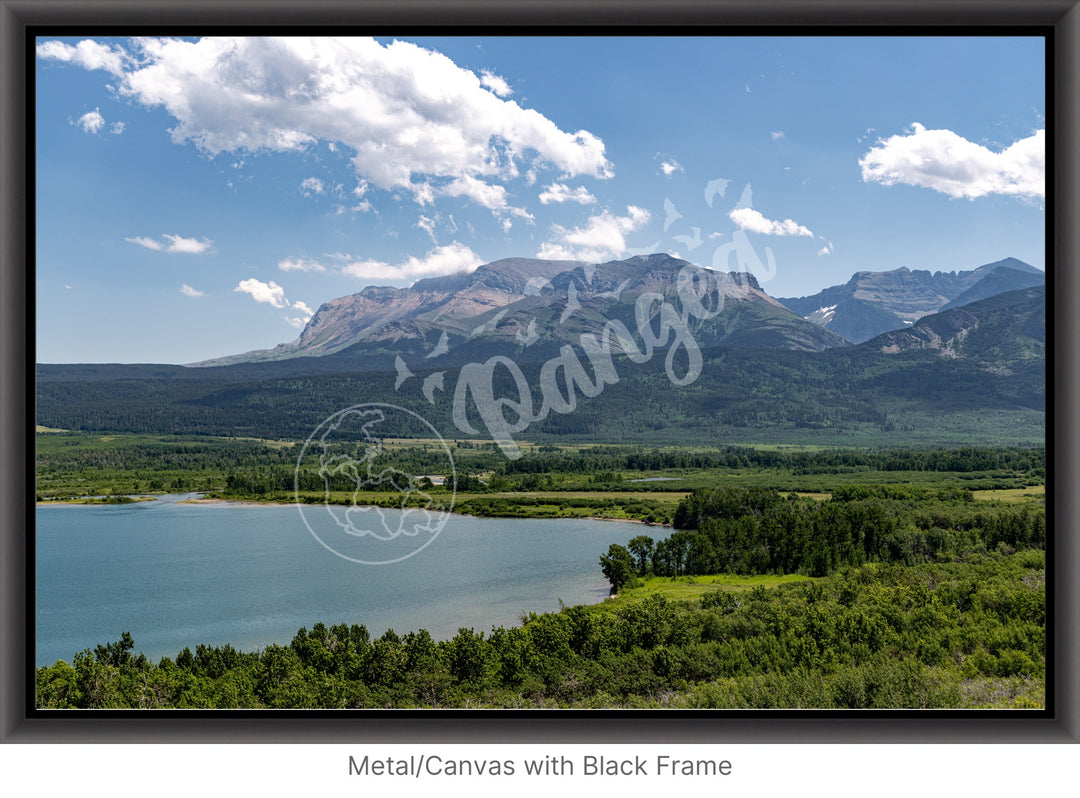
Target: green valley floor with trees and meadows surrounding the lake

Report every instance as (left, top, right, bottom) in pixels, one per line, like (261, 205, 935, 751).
(37, 433, 1047, 709)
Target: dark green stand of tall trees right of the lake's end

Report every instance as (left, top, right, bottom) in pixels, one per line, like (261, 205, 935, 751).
(600, 486, 1045, 593)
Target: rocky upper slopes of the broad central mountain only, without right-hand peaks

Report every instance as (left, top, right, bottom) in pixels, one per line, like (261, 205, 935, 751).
(191, 254, 846, 366)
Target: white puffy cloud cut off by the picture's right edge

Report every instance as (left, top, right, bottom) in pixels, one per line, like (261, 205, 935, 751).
(859, 122, 1047, 200)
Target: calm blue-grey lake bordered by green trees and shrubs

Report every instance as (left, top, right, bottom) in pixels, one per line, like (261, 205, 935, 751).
(36, 496, 654, 665)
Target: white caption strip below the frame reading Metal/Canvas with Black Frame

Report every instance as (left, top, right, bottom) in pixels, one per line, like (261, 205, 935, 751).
(0, 742, 1080, 798)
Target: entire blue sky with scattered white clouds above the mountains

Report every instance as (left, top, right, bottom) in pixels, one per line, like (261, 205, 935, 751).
(36, 37, 1045, 363)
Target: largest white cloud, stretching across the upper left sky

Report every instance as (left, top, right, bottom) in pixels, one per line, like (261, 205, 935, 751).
(38, 37, 613, 209)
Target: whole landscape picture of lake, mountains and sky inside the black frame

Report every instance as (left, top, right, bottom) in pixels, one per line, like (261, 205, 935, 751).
(28, 30, 1054, 716)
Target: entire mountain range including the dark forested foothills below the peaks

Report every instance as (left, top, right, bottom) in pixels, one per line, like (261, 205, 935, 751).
(36, 255, 1045, 446)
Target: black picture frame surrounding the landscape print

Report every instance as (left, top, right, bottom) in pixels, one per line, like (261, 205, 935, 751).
(0, 0, 1080, 743)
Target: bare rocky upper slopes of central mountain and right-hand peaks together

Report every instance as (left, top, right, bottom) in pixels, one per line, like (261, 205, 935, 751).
(191, 254, 1044, 367)
